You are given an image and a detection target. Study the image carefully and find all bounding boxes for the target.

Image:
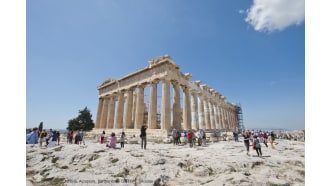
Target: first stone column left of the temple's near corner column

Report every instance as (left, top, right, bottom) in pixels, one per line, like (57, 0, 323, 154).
(148, 80, 159, 129)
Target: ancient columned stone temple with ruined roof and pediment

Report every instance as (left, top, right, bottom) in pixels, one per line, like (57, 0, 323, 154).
(94, 55, 239, 135)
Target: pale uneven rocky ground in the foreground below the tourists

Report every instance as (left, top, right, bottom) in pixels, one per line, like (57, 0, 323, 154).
(26, 139, 305, 186)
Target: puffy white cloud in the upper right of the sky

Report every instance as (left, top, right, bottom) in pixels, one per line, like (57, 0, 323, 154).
(245, 0, 305, 32)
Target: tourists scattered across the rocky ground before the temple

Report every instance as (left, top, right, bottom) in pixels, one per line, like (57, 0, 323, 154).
(26, 125, 276, 157)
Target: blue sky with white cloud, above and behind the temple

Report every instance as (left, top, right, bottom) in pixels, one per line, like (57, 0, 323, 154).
(26, 0, 305, 129)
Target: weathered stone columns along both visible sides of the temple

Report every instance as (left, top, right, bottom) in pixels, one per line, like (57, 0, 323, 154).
(95, 79, 238, 130)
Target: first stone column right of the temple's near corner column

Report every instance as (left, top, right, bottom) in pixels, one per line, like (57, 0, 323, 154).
(172, 81, 181, 129)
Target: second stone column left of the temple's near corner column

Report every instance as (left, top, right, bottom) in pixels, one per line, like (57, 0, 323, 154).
(134, 84, 146, 129)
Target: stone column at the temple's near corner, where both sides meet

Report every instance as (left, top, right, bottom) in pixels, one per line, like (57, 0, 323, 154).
(161, 79, 171, 130)
